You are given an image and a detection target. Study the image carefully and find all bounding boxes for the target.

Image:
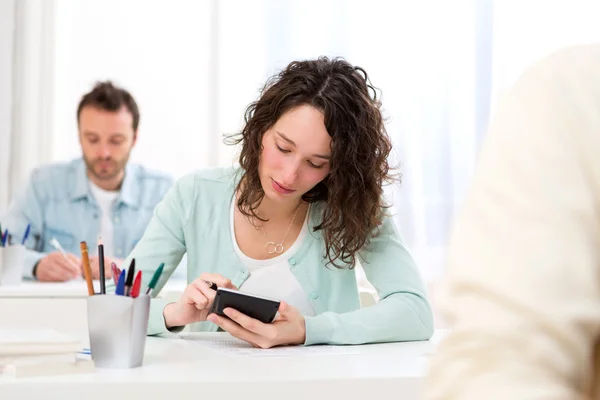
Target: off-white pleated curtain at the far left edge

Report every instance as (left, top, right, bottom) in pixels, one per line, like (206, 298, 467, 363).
(0, 0, 55, 212)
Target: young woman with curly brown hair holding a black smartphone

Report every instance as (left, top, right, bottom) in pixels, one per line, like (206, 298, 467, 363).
(124, 58, 433, 348)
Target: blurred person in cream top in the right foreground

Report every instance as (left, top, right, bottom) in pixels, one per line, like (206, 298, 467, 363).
(426, 45, 600, 400)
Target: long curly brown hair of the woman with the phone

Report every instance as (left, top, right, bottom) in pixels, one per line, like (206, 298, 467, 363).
(226, 57, 394, 269)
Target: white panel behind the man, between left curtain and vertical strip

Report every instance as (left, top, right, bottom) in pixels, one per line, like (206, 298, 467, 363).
(52, 0, 218, 175)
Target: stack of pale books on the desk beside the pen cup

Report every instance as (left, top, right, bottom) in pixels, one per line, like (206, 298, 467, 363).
(0, 328, 94, 380)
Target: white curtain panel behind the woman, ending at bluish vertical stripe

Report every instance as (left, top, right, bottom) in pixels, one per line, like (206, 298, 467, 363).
(218, 0, 492, 279)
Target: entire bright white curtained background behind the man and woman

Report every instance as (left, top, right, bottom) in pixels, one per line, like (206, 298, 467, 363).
(8, 0, 600, 280)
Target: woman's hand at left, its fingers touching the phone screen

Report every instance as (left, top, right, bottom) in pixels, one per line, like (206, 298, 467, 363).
(163, 273, 237, 328)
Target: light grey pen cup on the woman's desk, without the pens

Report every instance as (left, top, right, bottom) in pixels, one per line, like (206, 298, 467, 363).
(87, 295, 150, 368)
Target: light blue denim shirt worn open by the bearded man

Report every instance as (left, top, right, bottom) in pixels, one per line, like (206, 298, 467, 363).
(0, 159, 173, 278)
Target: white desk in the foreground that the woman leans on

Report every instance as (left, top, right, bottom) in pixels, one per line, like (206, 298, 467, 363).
(0, 332, 445, 400)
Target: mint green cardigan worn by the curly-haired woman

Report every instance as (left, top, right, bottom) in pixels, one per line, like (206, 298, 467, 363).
(123, 168, 433, 345)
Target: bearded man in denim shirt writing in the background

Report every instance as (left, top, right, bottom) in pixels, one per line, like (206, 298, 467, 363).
(0, 82, 172, 281)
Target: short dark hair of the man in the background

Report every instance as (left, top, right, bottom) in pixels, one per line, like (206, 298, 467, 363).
(77, 81, 140, 131)
